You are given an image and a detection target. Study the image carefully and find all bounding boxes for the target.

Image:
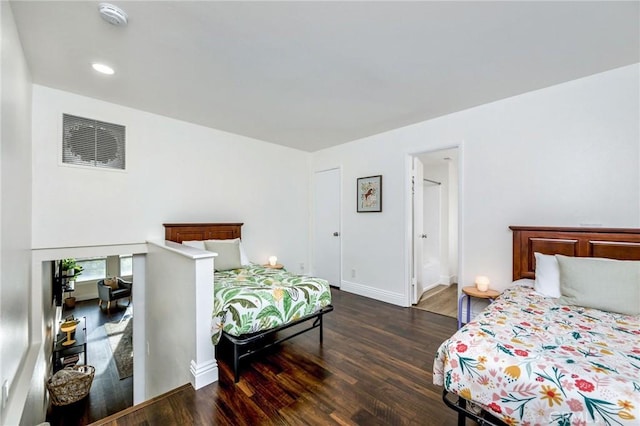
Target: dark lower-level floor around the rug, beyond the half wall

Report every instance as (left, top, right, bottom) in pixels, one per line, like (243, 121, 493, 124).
(47, 299, 133, 426)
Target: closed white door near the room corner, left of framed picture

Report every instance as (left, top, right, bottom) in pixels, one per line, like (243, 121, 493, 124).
(313, 169, 342, 287)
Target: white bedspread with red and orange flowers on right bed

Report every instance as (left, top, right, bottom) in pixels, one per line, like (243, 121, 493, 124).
(433, 286, 640, 425)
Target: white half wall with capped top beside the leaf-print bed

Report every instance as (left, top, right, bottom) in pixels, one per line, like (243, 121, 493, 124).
(145, 241, 218, 399)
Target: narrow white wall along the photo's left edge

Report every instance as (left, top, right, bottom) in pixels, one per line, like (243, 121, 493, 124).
(0, 1, 34, 424)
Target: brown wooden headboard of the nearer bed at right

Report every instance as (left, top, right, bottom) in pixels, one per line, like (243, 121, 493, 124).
(509, 226, 640, 281)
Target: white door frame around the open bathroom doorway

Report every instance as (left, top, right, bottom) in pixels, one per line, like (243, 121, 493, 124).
(404, 145, 464, 307)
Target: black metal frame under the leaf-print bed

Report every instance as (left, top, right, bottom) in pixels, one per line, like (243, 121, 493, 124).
(222, 305, 333, 383)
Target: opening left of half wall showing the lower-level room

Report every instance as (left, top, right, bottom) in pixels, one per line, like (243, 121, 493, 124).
(47, 254, 134, 426)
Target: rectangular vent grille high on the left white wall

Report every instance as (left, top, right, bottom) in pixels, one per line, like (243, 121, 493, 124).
(62, 114, 125, 170)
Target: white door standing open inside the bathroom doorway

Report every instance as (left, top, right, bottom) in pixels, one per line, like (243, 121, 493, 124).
(411, 157, 424, 304)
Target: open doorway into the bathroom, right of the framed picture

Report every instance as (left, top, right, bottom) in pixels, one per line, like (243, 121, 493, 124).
(410, 147, 459, 318)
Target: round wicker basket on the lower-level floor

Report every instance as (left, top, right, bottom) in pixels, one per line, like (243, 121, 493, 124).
(47, 365, 96, 406)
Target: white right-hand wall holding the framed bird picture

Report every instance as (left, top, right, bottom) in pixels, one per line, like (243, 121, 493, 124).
(311, 64, 640, 305)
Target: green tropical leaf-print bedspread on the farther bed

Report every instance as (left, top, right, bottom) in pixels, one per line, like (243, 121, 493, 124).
(211, 264, 331, 345)
